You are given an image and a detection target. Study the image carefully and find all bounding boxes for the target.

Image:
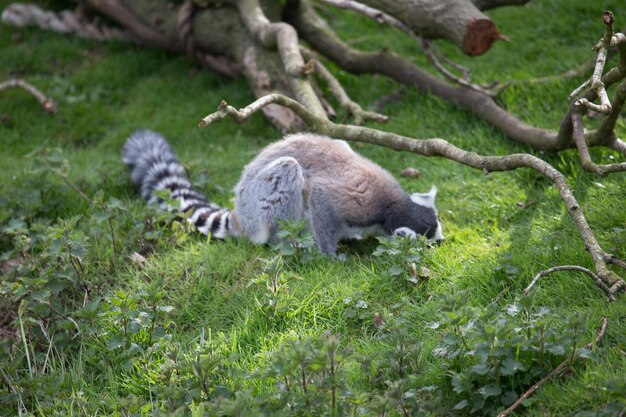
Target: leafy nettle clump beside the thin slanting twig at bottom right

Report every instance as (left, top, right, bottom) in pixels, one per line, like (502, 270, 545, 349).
(431, 292, 595, 415)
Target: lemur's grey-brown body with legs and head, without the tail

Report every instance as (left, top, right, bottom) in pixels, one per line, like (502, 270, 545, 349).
(235, 134, 443, 254)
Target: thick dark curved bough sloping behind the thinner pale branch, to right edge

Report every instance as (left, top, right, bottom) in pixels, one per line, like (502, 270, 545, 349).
(287, 0, 626, 151)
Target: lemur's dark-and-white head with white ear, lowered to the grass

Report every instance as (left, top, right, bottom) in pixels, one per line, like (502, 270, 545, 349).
(393, 185, 444, 244)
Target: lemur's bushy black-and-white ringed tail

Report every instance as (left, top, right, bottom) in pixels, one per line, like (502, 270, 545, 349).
(122, 130, 238, 239)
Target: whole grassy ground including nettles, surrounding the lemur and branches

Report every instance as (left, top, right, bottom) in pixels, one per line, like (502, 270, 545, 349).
(0, 0, 626, 416)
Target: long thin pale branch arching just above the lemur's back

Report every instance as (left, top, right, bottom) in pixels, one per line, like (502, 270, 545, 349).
(199, 94, 626, 294)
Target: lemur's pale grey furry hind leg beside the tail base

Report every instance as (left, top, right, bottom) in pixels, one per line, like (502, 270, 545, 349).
(235, 156, 305, 243)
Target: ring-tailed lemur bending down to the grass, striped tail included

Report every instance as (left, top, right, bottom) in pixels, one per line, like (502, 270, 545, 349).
(122, 130, 443, 255)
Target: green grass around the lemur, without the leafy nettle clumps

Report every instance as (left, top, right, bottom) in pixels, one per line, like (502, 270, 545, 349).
(0, 0, 626, 416)
